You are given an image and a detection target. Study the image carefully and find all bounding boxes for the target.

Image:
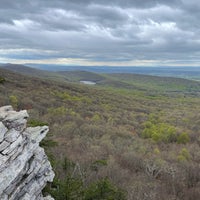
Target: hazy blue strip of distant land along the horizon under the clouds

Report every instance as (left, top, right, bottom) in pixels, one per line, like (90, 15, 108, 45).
(29, 64, 200, 80)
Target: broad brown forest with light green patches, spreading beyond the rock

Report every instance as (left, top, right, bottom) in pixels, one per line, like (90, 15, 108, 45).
(0, 69, 200, 200)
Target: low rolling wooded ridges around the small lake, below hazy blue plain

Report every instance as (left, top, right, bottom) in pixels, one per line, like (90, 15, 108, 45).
(0, 64, 200, 95)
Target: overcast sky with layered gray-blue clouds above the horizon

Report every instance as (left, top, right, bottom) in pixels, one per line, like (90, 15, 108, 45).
(0, 0, 200, 66)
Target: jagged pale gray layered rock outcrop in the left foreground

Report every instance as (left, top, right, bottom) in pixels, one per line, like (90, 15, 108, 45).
(0, 106, 54, 200)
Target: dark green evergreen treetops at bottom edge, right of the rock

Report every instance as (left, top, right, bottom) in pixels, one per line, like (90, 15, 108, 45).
(43, 176, 127, 200)
